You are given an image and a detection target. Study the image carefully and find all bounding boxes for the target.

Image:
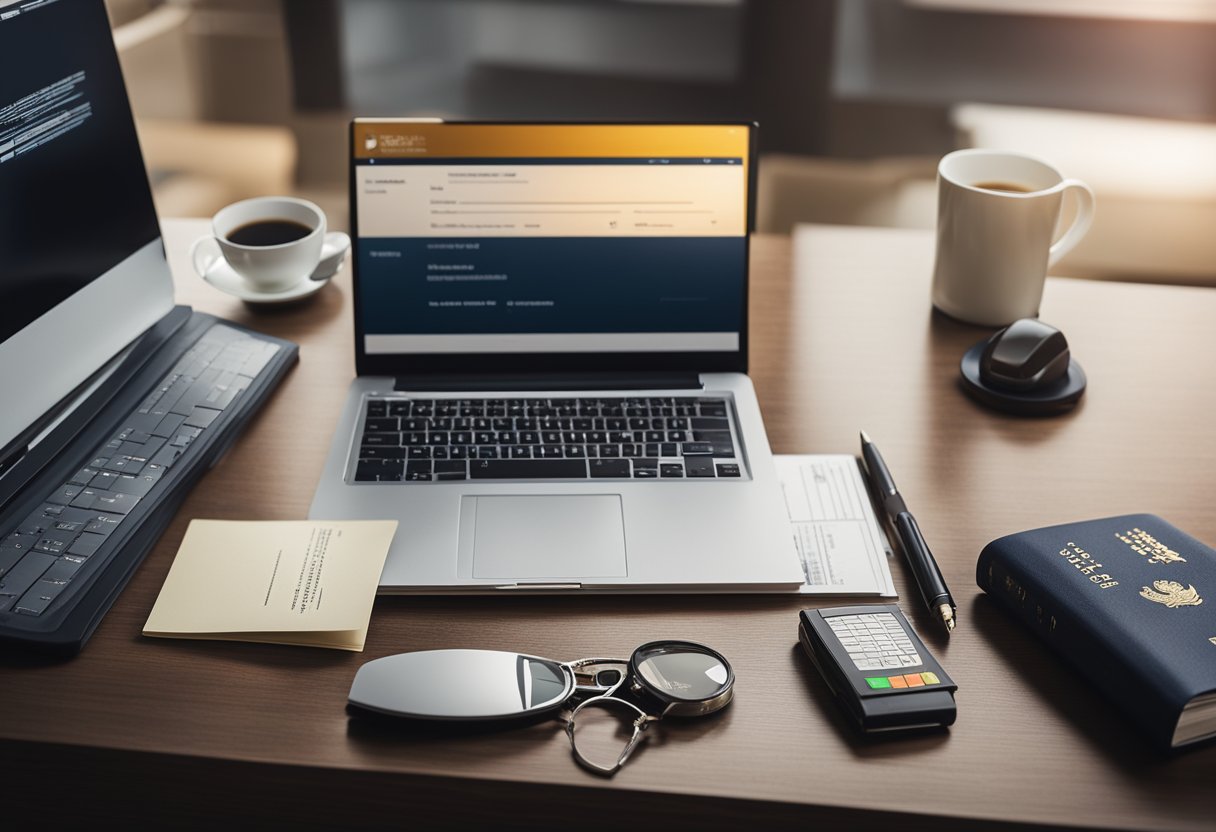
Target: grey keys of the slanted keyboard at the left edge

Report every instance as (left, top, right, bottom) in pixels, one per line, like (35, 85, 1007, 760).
(0, 324, 292, 641)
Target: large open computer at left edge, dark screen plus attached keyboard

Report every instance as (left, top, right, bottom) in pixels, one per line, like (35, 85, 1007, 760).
(0, 0, 298, 653)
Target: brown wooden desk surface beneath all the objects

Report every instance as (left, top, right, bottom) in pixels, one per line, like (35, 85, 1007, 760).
(0, 220, 1216, 830)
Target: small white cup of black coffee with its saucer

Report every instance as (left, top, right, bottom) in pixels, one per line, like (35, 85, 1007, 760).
(190, 196, 350, 293)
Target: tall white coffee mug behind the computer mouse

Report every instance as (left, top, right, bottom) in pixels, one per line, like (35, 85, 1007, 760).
(933, 150, 1093, 326)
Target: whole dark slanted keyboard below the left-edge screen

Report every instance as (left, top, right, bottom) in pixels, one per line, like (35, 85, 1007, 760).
(0, 308, 295, 648)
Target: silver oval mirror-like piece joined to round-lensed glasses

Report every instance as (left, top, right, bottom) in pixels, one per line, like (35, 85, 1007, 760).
(347, 641, 734, 775)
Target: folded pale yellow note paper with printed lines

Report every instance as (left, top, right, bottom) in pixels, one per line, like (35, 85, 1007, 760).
(143, 519, 396, 651)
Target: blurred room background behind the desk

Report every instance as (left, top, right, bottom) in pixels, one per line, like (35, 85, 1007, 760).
(107, 0, 1216, 285)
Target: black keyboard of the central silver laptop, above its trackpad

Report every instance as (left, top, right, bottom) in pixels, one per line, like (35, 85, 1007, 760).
(354, 397, 743, 483)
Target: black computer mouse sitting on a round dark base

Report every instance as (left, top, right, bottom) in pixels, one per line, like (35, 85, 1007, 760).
(980, 317, 1071, 392)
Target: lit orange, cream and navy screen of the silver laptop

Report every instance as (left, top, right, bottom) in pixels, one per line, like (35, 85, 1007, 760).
(353, 120, 749, 354)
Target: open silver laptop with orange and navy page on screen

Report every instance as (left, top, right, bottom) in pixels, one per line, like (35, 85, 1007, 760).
(309, 119, 803, 594)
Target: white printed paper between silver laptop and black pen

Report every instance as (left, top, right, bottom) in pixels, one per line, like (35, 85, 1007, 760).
(773, 454, 896, 597)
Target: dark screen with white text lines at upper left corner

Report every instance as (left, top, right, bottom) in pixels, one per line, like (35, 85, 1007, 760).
(0, 0, 159, 343)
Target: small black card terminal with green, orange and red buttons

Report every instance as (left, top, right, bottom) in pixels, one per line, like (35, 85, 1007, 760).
(798, 603, 958, 732)
